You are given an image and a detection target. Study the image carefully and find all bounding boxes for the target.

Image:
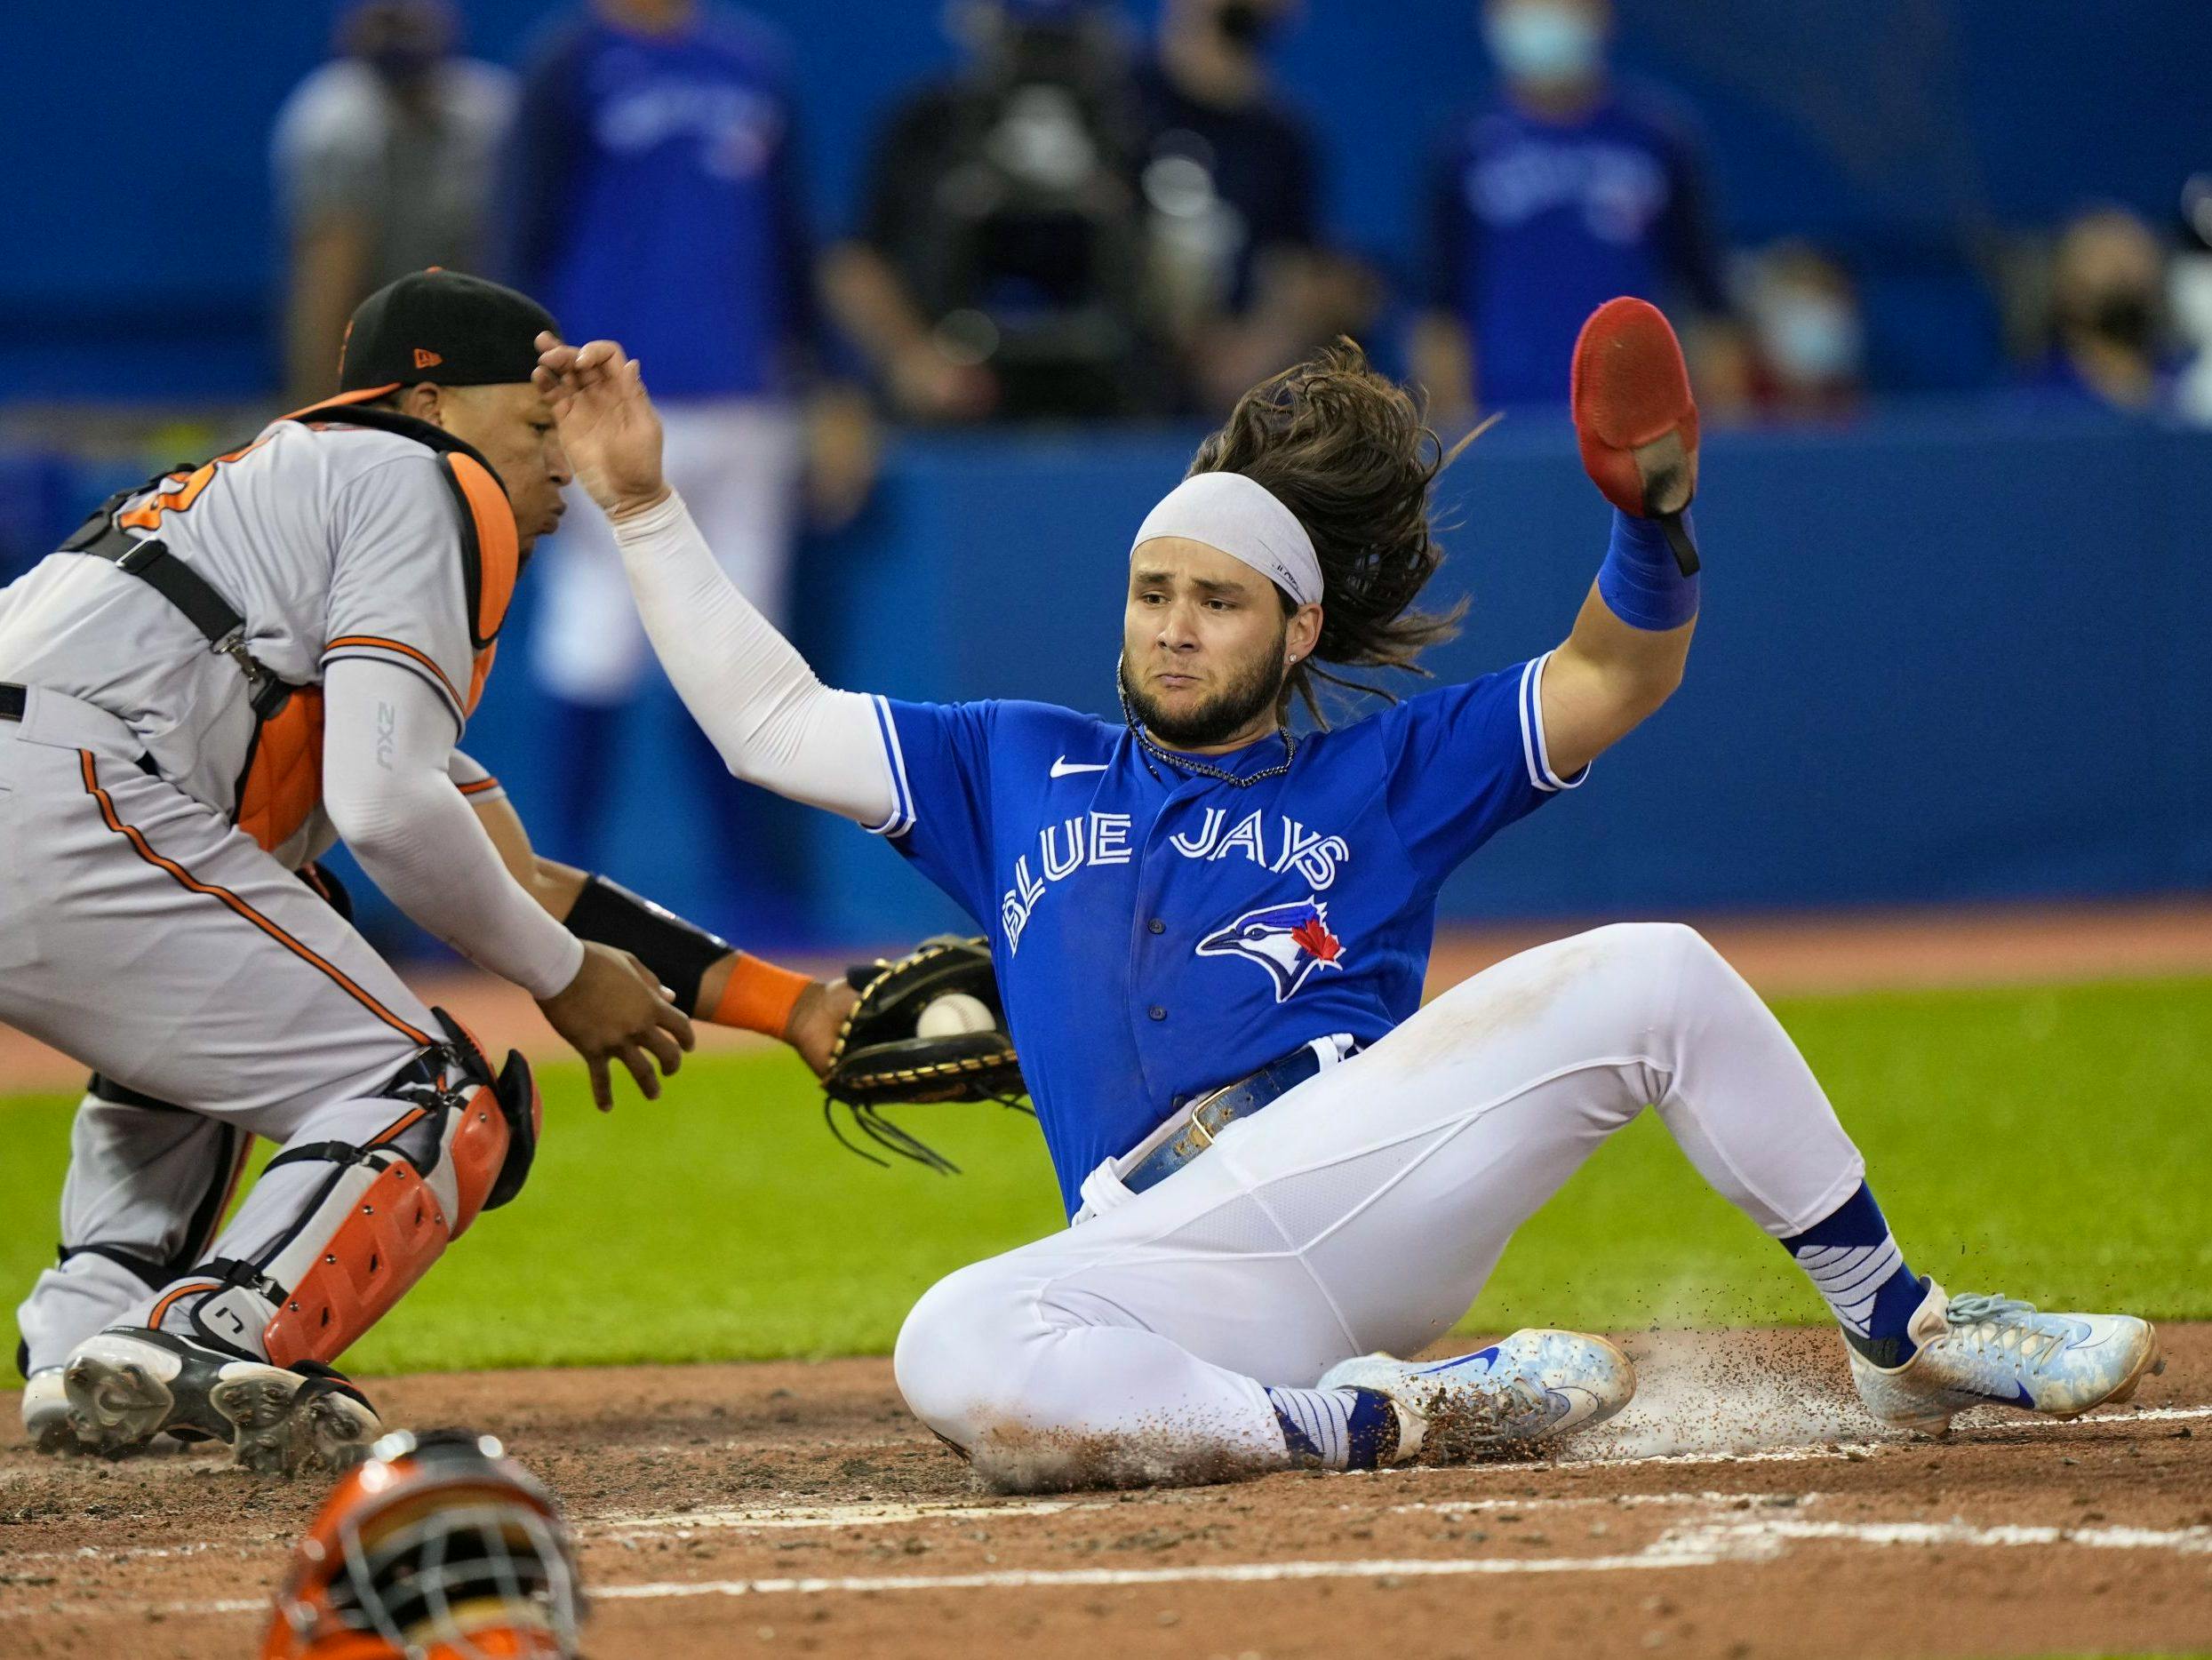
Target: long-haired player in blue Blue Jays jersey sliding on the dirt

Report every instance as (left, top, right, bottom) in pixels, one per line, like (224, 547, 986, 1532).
(553, 311, 2157, 1485)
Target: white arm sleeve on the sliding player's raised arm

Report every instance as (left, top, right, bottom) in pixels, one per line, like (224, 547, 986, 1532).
(615, 491, 898, 826)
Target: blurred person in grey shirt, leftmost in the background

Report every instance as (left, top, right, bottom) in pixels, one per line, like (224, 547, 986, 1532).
(270, 0, 515, 404)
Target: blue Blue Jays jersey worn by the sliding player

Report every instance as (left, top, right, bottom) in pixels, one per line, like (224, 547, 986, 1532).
(874, 657, 1579, 1211)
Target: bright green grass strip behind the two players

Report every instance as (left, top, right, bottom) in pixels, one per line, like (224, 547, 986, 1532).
(0, 979, 2212, 1373)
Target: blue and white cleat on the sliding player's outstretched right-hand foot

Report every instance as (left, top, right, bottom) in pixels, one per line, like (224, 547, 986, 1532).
(1851, 1280, 2166, 1434)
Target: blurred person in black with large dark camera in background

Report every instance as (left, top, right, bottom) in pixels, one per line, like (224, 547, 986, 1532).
(827, 0, 1175, 422)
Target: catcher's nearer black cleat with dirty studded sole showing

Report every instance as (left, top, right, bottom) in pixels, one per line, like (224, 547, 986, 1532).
(62, 1326, 383, 1474)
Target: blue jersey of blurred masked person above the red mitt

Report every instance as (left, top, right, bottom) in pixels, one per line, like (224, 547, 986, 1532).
(1429, 97, 1728, 404)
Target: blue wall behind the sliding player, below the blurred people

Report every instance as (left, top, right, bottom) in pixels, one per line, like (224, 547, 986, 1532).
(453, 407, 2212, 939)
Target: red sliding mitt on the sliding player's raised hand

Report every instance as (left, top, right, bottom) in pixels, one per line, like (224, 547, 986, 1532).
(1570, 299, 1699, 577)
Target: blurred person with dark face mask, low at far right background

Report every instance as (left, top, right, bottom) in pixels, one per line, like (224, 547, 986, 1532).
(2022, 205, 2181, 413)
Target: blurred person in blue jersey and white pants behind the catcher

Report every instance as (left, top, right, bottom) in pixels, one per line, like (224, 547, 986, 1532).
(502, 0, 874, 933)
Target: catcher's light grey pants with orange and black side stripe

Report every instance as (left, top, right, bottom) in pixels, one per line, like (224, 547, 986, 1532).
(0, 690, 458, 1369)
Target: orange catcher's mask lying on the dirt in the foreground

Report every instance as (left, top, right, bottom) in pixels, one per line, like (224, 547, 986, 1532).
(261, 1430, 582, 1660)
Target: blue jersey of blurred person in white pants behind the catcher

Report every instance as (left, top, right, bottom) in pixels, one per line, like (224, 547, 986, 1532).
(502, 9, 816, 398)
